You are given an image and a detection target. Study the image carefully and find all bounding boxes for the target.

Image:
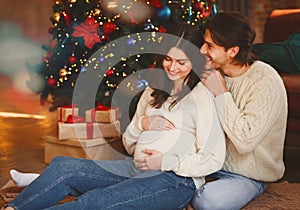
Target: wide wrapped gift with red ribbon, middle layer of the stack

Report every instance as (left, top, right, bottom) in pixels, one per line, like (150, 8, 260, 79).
(58, 120, 121, 140)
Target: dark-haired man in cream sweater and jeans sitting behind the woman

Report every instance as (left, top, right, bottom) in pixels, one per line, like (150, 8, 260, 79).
(192, 12, 287, 210)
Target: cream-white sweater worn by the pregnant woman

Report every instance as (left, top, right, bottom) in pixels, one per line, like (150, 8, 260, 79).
(123, 83, 226, 187)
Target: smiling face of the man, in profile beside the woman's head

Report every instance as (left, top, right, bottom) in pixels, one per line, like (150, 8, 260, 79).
(200, 30, 231, 70)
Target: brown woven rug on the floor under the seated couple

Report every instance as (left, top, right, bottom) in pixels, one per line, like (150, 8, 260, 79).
(0, 180, 300, 210)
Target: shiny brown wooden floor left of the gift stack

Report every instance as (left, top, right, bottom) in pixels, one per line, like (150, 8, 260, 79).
(0, 75, 54, 186)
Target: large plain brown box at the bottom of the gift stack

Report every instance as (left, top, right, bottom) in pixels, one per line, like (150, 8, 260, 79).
(43, 136, 125, 163)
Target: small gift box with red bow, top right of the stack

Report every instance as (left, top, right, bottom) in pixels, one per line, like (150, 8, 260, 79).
(85, 104, 120, 123)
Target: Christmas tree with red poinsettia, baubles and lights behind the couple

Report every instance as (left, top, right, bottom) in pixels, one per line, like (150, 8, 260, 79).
(27, 0, 217, 116)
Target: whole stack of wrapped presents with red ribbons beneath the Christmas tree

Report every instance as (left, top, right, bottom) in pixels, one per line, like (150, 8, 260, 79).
(44, 105, 124, 163)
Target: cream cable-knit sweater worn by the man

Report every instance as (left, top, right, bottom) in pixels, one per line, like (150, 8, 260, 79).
(215, 61, 287, 182)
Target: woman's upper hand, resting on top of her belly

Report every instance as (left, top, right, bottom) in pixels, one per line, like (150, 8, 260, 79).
(141, 115, 175, 131)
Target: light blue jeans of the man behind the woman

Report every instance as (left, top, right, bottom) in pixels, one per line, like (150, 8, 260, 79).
(192, 171, 267, 210)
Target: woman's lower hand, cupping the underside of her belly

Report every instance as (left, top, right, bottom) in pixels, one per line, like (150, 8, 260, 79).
(134, 149, 162, 171)
